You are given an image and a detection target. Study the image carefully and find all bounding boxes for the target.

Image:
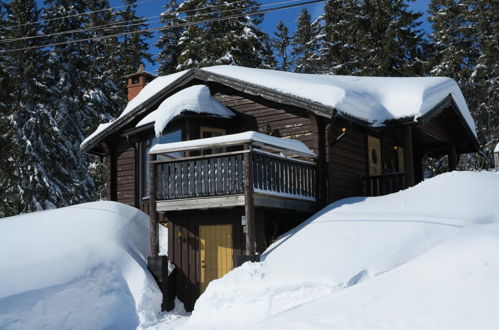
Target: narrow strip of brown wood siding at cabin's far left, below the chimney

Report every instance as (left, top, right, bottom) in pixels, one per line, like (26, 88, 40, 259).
(115, 146, 136, 206)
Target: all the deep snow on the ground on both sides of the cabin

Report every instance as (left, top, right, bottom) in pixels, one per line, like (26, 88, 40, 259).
(0, 172, 499, 330)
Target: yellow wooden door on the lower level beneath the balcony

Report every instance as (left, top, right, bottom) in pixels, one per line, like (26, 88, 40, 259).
(199, 225, 234, 293)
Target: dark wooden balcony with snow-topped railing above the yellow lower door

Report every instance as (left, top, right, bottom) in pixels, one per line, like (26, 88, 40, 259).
(152, 132, 317, 212)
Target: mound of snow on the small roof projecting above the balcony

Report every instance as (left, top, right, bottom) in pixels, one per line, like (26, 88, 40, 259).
(137, 85, 235, 136)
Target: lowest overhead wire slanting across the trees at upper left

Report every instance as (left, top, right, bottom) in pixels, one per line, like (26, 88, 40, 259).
(0, 0, 326, 53)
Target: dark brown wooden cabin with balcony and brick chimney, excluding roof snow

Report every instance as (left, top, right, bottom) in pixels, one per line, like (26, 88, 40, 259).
(82, 65, 478, 310)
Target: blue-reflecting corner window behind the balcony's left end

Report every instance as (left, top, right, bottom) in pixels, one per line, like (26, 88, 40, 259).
(139, 128, 182, 198)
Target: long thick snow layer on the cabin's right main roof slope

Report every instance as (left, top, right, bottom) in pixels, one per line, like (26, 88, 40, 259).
(202, 65, 476, 134)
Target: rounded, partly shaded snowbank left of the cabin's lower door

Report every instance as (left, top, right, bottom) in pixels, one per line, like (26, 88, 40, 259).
(0, 202, 161, 329)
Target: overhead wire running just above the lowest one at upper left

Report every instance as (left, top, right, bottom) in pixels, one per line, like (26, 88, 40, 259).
(0, 0, 300, 44)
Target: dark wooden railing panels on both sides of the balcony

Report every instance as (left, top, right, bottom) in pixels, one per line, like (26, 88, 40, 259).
(155, 150, 316, 200)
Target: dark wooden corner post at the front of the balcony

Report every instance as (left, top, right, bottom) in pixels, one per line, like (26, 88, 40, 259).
(243, 144, 256, 255)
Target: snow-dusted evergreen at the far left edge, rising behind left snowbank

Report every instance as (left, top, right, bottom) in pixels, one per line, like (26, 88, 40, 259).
(2, 0, 82, 215)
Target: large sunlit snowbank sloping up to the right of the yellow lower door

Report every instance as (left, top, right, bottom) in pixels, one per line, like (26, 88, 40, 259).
(186, 172, 499, 329)
